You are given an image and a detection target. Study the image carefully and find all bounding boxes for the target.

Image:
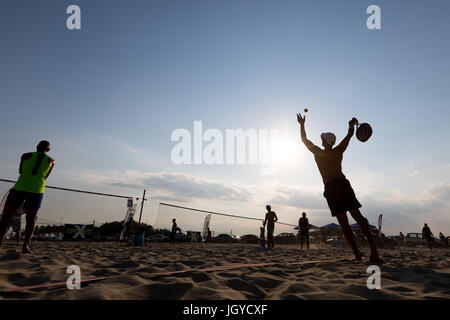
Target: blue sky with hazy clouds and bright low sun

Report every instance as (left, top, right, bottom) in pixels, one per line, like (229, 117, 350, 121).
(0, 0, 450, 234)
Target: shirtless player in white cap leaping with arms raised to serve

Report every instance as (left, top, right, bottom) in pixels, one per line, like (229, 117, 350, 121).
(297, 113, 383, 263)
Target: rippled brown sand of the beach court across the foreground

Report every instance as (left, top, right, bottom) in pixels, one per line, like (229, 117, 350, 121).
(0, 242, 450, 300)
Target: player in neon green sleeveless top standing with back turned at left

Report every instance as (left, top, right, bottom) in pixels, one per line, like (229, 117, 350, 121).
(0, 141, 55, 253)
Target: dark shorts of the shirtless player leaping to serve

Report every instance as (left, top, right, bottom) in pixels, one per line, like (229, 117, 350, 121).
(323, 179, 362, 217)
